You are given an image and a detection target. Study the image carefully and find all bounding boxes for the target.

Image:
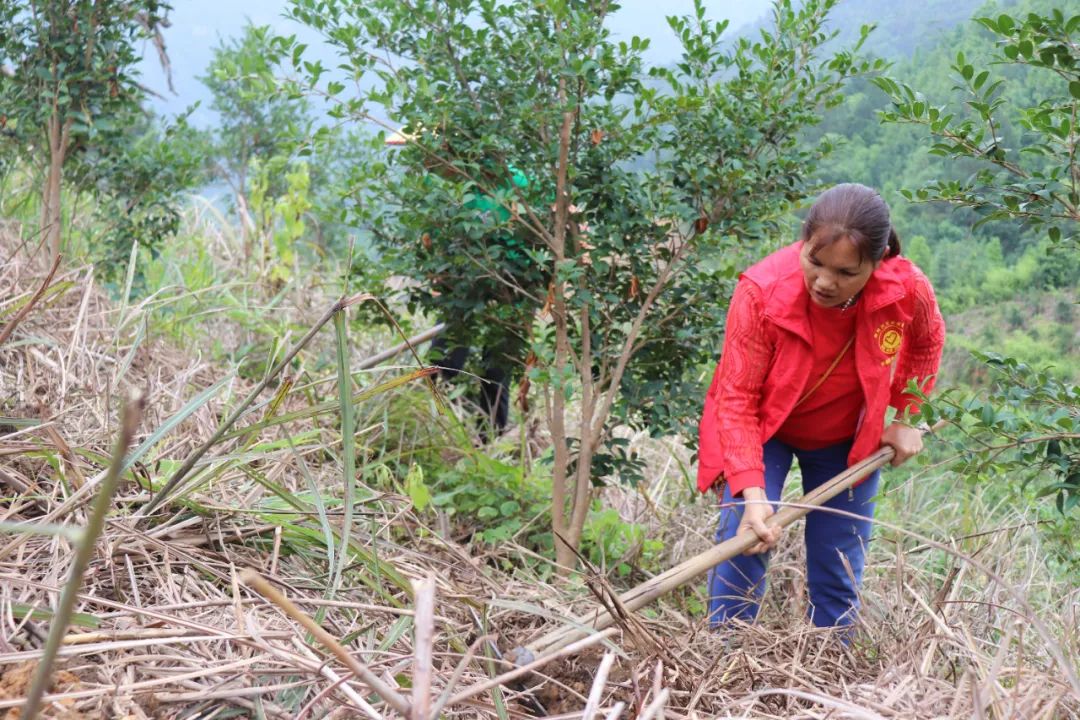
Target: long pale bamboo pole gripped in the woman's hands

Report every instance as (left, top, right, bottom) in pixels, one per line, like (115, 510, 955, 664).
(516, 431, 942, 658)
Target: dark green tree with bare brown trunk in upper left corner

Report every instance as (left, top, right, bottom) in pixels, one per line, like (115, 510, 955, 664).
(0, 0, 168, 264)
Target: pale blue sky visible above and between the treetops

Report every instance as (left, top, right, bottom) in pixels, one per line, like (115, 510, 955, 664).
(141, 0, 771, 127)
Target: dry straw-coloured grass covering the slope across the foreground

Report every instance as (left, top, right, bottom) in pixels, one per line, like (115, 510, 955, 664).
(0, 226, 1080, 719)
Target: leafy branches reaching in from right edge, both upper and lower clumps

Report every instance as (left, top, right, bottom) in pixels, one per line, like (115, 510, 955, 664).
(875, 9, 1080, 544)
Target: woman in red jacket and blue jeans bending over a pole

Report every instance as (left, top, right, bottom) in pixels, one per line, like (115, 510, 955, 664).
(698, 185, 945, 627)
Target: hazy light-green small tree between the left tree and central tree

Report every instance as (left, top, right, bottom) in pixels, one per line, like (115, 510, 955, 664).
(200, 24, 384, 262)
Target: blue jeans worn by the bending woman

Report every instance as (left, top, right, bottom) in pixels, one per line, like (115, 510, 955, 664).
(708, 438, 881, 627)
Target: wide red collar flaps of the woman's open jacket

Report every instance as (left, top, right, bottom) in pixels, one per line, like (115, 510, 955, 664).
(746, 241, 907, 342)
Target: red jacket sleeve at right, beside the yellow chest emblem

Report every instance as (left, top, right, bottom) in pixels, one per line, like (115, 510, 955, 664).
(889, 272, 945, 412)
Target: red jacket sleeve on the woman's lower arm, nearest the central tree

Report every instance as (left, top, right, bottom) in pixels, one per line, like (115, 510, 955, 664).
(698, 280, 775, 497)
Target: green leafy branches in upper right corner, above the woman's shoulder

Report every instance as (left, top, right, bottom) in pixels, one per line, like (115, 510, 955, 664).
(874, 9, 1080, 244)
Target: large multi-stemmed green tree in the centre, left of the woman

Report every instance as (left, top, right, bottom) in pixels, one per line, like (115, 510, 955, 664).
(279, 0, 870, 569)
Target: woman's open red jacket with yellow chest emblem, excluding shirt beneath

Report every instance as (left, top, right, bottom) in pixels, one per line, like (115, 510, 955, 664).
(698, 242, 945, 495)
